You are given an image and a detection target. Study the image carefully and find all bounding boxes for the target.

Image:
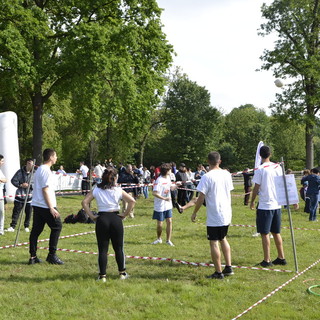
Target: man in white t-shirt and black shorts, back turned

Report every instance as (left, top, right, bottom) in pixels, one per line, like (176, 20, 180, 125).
(191, 151, 234, 279)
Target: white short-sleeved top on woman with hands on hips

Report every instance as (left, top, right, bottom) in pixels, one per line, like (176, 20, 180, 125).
(92, 187, 122, 212)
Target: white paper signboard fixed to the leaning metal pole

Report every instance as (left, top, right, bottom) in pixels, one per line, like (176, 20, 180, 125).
(274, 174, 299, 206)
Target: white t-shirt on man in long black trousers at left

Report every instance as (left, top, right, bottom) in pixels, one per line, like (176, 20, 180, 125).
(31, 164, 57, 209)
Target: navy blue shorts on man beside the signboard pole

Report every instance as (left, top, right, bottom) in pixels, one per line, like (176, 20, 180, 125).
(256, 209, 281, 234)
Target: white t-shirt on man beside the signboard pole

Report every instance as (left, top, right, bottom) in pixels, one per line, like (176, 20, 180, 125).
(252, 162, 282, 210)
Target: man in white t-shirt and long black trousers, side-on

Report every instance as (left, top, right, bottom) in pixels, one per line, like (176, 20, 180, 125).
(29, 149, 64, 265)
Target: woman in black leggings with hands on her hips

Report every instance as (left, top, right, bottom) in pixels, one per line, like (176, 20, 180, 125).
(82, 167, 136, 282)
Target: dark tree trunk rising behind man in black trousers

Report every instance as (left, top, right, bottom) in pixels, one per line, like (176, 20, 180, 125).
(32, 92, 43, 165)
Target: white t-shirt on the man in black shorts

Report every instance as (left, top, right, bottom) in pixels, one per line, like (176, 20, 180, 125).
(197, 169, 233, 227)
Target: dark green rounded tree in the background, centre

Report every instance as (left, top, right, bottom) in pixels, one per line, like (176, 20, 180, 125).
(147, 70, 222, 166)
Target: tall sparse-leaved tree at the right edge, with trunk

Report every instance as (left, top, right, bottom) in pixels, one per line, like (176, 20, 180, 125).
(260, 0, 320, 168)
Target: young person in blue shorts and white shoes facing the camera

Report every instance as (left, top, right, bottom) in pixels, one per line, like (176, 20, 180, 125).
(152, 163, 179, 247)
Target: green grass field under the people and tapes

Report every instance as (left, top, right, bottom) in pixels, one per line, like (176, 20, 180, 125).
(0, 185, 320, 320)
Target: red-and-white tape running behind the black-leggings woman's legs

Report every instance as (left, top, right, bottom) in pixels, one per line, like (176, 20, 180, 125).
(38, 247, 292, 272)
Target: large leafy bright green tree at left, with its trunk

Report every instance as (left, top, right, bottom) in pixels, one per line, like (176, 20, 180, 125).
(0, 0, 172, 161)
